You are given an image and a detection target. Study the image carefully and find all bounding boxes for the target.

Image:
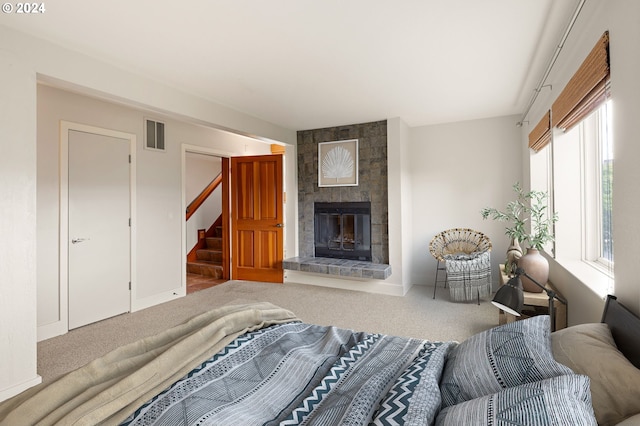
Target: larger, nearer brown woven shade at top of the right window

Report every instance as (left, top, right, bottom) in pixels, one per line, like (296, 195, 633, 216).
(551, 31, 610, 131)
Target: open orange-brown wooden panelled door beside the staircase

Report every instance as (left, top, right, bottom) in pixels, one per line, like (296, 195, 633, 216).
(231, 155, 284, 283)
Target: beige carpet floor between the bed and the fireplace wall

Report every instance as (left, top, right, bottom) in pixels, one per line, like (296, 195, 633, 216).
(38, 281, 498, 382)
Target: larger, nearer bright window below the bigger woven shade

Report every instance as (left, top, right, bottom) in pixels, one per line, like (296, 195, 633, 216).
(551, 101, 614, 294)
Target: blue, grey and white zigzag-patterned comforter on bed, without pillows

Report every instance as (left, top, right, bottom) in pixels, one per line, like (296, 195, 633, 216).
(123, 322, 452, 426)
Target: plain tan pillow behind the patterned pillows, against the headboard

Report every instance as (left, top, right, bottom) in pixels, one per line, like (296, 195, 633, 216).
(551, 323, 640, 425)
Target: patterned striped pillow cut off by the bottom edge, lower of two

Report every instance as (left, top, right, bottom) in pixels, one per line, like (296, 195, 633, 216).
(436, 374, 596, 426)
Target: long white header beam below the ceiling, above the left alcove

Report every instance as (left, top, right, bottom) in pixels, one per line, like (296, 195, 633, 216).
(0, 25, 296, 144)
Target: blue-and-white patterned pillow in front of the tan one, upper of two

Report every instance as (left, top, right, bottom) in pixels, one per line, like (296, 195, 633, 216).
(440, 315, 573, 407)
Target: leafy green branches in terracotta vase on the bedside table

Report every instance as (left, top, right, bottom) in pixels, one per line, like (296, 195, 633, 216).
(480, 182, 558, 292)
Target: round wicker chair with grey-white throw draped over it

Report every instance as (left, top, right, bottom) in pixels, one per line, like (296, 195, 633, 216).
(429, 228, 491, 304)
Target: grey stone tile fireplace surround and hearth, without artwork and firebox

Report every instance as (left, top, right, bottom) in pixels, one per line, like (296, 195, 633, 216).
(284, 120, 391, 279)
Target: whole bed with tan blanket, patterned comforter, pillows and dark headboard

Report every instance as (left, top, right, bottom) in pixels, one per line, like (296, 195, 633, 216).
(0, 296, 640, 425)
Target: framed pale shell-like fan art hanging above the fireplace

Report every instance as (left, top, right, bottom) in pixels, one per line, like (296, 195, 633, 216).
(318, 139, 358, 186)
